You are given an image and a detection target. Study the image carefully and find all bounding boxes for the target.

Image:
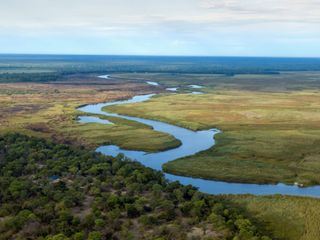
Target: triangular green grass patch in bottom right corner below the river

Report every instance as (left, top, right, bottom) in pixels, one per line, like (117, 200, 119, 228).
(223, 195, 320, 240)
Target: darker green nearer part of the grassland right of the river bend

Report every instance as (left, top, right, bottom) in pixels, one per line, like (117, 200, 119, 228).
(164, 129, 320, 185)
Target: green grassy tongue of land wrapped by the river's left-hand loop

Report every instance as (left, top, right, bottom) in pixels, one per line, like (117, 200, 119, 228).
(60, 113, 180, 152)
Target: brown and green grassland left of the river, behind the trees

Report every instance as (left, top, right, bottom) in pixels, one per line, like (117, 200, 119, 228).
(0, 76, 180, 152)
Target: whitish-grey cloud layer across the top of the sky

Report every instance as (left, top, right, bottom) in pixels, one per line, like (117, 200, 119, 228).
(0, 0, 320, 34)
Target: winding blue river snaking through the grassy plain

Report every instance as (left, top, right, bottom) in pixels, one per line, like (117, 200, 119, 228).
(79, 90, 320, 197)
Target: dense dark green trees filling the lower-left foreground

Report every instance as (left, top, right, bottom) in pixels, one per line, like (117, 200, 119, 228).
(0, 134, 269, 240)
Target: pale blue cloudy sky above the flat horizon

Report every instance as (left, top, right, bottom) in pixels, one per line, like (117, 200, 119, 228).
(0, 0, 320, 57)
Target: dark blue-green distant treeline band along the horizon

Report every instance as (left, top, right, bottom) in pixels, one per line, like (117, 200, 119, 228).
(0, 55, 320, 82)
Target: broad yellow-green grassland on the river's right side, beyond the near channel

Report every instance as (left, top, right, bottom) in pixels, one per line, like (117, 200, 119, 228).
(105, 73, 320, 185)
